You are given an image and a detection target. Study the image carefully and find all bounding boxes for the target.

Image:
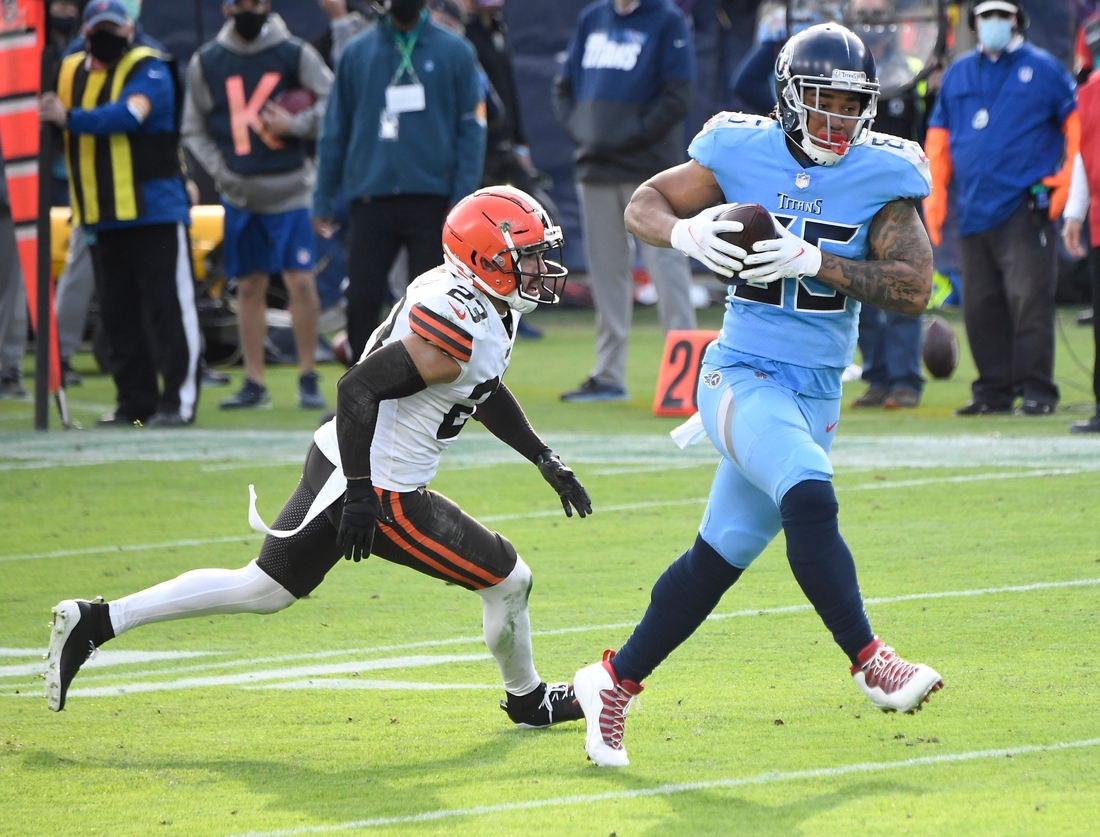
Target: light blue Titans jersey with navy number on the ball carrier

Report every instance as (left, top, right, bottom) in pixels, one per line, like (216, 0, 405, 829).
(688, 112, 932, 398)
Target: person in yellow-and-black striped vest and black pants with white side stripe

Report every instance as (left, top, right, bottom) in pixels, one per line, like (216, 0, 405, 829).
(39, 0, 199, 427)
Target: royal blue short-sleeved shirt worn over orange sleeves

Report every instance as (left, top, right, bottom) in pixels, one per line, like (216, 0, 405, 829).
(928, 42, 1077, 235)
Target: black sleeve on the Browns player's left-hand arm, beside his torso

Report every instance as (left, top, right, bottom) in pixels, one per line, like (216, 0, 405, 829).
(337, 341, 428, 480)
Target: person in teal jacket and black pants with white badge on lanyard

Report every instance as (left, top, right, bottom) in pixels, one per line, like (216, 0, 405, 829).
(314, 0, 485, 357)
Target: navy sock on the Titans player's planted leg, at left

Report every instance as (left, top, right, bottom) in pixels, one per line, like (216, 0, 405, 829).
(612, 537, 743, 683)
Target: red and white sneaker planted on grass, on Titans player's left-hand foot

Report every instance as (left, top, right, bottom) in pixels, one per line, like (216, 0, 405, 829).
(573, 651, 645, 768)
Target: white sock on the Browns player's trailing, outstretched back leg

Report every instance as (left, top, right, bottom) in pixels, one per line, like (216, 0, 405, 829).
(109, 561, 297, 636)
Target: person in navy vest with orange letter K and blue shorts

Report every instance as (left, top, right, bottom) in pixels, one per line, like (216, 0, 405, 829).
(183, 0, 332, 409)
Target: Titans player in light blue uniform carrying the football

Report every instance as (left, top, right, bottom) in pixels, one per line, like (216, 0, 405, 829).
(574, 23, 943, 767)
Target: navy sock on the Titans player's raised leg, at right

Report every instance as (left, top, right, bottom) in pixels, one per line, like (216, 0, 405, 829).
(780, 480, 875, 664)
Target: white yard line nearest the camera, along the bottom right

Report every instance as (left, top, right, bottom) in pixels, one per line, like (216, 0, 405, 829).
(225, 738, 1100, 837)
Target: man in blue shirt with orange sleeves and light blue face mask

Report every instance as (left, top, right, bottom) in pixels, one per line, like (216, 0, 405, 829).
(924, 0, 1079, 416)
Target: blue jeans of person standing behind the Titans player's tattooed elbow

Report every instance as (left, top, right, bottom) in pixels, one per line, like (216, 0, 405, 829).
(859, 305, 924, 394)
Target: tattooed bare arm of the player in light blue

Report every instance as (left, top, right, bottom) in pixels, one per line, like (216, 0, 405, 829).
(814, 200, 932, 317)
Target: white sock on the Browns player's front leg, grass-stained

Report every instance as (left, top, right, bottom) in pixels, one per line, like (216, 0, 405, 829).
(477, 559, 542, 695)
